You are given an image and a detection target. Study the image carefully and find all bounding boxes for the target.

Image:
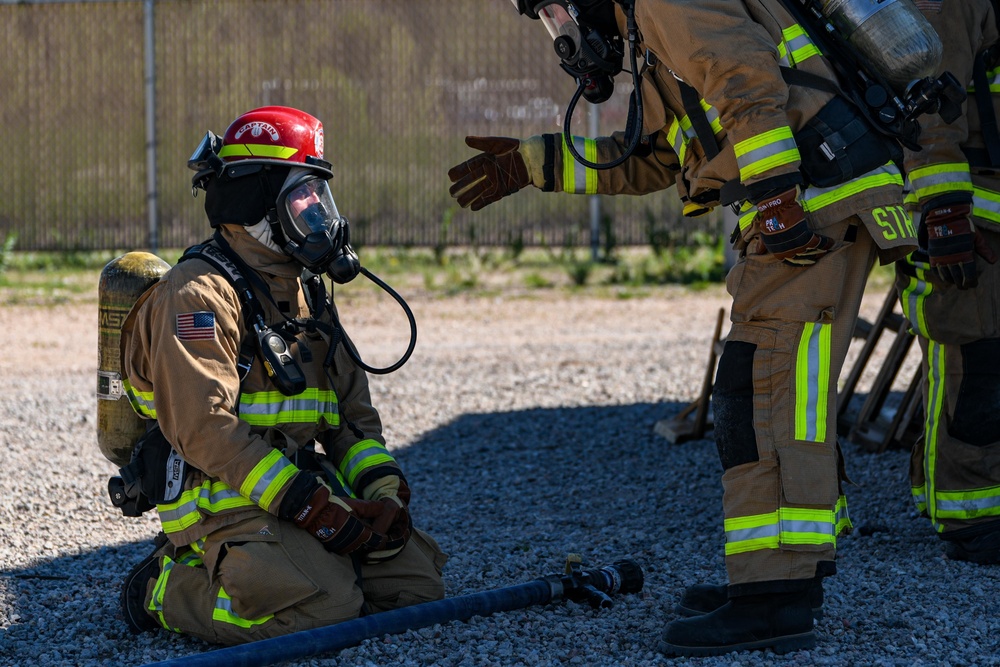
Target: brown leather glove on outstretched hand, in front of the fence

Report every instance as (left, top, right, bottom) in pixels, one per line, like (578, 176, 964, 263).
(448, 136, 545, 211)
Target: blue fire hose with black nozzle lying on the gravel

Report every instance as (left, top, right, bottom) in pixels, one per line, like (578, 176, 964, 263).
(144, 556, 643, 667)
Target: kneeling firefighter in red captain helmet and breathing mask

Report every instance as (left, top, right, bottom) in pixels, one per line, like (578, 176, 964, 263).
(103, 107, 446, 644)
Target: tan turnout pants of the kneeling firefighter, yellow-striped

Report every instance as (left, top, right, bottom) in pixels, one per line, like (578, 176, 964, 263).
(140, 515, 446, 645)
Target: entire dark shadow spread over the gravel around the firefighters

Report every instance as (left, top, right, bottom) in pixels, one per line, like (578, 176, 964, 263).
(7, 397, 1000, 667)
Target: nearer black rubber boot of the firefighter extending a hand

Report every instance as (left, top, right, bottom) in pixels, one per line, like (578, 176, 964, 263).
(658, 591, 816, 657)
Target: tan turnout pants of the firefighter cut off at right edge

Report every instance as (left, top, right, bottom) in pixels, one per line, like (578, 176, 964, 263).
(896, 225, 1000, 537)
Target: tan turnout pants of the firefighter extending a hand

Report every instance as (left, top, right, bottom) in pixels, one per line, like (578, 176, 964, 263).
(712, 217, 876, 596)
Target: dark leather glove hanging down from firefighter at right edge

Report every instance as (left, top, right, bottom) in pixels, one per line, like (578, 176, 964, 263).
(921, 198, 997, 289)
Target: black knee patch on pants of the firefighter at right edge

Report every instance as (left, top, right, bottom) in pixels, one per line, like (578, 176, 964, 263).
(948, 338, 1000, 447)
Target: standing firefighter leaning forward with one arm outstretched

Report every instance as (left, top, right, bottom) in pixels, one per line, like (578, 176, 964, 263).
(449, 0, 954, 655)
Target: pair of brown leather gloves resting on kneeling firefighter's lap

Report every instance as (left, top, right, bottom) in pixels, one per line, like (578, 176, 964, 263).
(278, 471, 398, 555)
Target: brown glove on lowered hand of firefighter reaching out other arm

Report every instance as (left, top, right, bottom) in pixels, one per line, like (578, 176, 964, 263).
(757, 188, 833, 266)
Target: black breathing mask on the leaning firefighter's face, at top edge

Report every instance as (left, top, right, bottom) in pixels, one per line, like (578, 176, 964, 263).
(511, 0, 624, 104)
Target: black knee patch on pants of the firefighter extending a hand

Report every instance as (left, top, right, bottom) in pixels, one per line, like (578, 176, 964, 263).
(712, 341, 760, 470)
